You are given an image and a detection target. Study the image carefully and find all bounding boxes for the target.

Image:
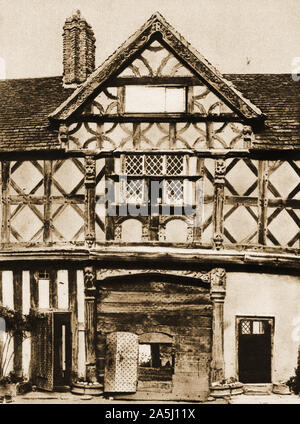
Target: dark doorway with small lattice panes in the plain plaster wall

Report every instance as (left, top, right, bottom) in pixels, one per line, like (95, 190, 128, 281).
(238, 318, 273, 383)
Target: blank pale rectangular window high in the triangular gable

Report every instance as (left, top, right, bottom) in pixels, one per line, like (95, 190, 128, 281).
(125, 85, 186, 113)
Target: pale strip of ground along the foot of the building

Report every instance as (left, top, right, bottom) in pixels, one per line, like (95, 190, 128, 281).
(4, 392, 300, 404)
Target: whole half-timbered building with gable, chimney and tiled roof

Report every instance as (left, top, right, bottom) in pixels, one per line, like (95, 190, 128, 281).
(0, 12, 300, 400)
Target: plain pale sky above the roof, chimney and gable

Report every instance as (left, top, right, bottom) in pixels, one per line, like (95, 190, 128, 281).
(0, 0, 300, 78)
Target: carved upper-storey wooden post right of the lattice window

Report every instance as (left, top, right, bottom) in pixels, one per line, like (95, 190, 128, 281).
(213, 159, 226, 250)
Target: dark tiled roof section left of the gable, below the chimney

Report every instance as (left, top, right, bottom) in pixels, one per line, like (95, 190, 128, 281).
(0, 77, 73, 150)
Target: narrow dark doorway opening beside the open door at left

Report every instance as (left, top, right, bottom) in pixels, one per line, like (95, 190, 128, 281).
(53, 313, 71, 389)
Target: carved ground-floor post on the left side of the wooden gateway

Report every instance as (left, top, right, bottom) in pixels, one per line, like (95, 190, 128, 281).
(84, 266, 97, 383)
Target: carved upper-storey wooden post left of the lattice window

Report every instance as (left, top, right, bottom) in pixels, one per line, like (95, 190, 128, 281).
(84, 154, 96, 248)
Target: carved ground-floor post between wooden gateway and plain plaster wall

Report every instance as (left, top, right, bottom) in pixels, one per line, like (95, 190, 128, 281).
(210, 268, 226, 383)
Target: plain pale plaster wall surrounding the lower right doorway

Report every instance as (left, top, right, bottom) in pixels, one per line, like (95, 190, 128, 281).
(224, 272, 300, 382)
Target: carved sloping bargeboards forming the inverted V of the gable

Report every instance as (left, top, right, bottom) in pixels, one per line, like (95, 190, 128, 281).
(49, 13, 265, 121)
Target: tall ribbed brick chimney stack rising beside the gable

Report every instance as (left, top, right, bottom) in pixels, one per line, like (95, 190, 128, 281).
(63, 10, 96, 85)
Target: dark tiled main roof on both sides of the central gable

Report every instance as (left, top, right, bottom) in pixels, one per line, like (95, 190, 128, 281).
(0, 74, 300, 151)
